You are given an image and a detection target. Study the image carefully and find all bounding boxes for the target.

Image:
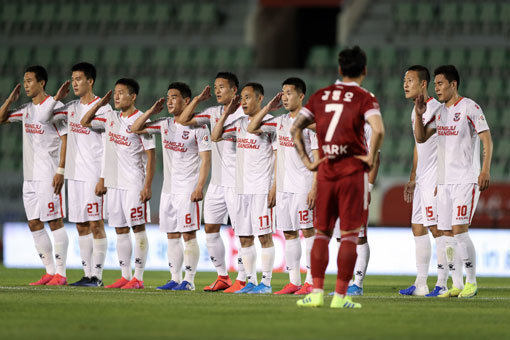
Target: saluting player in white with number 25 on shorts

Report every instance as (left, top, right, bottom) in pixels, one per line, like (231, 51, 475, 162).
(80, 78, 155, 289)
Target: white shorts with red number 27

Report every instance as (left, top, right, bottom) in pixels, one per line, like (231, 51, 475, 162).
(67, 179, 104, 223)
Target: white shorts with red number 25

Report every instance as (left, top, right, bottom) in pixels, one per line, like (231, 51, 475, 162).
(107, 188, 151, 228)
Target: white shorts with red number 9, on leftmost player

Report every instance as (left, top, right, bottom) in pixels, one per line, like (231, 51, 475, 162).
(23, 180, 66, 222)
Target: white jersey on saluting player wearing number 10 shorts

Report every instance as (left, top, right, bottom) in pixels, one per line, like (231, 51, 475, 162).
(436, 97, 489, 184)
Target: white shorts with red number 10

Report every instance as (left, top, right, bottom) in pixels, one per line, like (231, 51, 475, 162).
(437, 183, 480, 230)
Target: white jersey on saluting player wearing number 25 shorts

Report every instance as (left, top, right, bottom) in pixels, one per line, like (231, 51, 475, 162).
(91, 110, 155, 190)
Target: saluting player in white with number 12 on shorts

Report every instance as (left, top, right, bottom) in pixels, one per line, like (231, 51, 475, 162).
(247, 78, 319, 295)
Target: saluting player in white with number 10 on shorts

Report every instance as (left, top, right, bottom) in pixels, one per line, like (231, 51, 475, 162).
(415, 65, 493, 298)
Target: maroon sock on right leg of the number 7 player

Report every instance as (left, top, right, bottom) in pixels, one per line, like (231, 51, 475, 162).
(335, 233, 358, 295)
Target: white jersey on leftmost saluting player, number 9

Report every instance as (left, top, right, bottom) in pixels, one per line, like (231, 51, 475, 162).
(7, 96, 67, 181)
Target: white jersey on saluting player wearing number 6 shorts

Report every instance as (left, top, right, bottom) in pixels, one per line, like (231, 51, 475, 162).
(146, 118, 211, 194)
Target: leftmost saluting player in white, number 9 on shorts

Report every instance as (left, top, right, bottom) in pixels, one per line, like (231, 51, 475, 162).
(0, 65, 69, 286)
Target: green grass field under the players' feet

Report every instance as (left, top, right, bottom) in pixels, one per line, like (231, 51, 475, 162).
(0, 267, 510, 340)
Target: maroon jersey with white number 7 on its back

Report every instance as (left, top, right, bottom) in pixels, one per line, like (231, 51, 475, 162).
(300, 81, 381, 181)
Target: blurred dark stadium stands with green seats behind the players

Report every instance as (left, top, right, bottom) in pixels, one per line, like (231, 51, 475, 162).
(0, 0, 510, 270)
